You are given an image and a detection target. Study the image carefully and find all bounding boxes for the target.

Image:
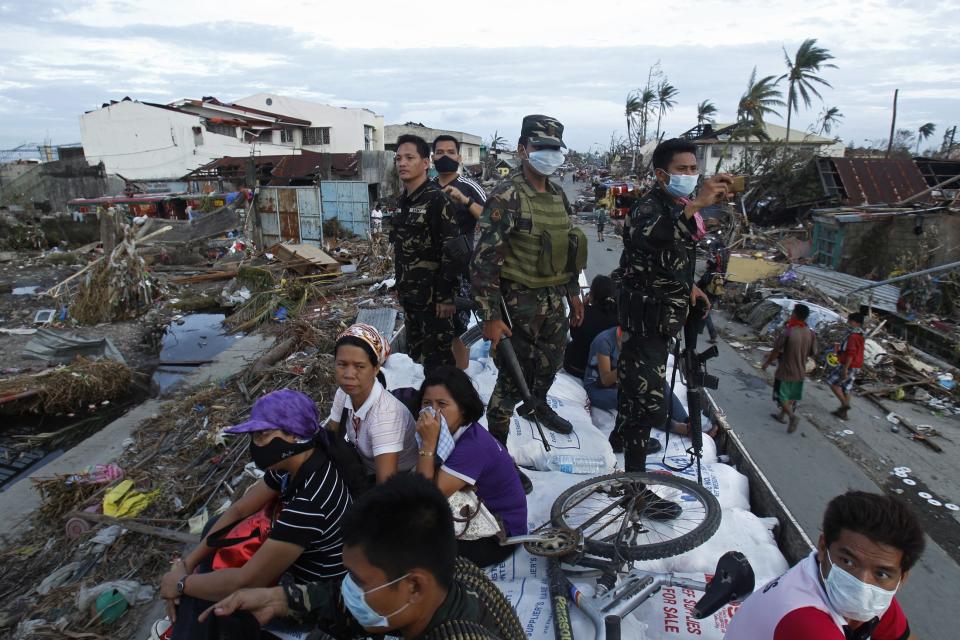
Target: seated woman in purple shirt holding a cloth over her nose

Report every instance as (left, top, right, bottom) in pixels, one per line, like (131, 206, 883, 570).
(417, 366, 527, 567)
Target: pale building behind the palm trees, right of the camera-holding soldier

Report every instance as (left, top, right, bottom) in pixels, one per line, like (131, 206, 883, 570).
(688, 123, 844, 176)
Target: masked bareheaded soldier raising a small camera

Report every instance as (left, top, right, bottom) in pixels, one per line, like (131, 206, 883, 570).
(610, 139, 730, 471)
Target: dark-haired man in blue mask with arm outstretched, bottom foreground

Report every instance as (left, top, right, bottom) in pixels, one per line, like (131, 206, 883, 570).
(203, 474, 526, 640)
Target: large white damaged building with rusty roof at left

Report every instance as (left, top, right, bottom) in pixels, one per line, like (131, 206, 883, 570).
(80, 94, 383, 180)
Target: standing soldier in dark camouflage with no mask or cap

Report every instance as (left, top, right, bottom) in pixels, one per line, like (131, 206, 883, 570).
(390, 135, 463, 370)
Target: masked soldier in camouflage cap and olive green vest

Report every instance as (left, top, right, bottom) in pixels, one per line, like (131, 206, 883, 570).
(472, 115, 587, 493)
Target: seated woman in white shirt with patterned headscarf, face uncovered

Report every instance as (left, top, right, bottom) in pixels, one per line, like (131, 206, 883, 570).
(327, 324, 417, 484)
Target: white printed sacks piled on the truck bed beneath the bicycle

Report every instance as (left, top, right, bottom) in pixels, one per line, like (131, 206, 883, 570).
(384, 354, 787, 640)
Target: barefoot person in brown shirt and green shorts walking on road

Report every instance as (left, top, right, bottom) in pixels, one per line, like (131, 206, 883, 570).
(761, 303, 817, 433)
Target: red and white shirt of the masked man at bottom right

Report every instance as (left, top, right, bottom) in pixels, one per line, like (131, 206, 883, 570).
(724, 552, 910, 640)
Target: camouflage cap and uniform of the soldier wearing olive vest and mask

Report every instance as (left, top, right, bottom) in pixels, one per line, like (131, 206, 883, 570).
(471, 116, 582, 444)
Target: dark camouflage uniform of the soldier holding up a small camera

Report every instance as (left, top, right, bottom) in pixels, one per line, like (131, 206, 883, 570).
(616, 185, 697, 471)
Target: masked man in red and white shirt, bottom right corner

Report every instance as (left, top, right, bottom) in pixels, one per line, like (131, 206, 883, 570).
(724, 491, 925, 640)
